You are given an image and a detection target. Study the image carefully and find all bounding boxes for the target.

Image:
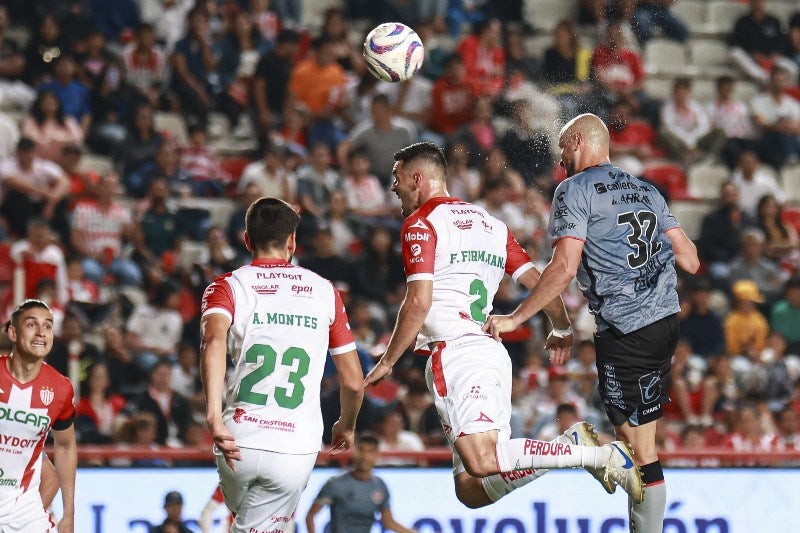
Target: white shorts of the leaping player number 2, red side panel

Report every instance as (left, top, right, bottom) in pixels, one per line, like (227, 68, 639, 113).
(425, 336, 511, 475)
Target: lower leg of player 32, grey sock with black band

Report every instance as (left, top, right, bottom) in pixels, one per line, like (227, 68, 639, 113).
(616, 420, 667, 533)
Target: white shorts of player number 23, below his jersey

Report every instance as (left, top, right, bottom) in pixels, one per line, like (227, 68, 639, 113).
(215, 448, 317, 533)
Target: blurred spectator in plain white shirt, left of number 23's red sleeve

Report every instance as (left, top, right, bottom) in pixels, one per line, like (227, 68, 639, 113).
(125, 281, 183, 370)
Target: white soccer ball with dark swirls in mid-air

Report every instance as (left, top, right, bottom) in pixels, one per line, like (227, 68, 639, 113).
(361, 22, 425, 82)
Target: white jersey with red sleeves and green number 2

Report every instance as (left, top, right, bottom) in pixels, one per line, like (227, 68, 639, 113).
(400, 197, 533, 353)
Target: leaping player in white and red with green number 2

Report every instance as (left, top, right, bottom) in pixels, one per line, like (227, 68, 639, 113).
(365, 143, 642, 507)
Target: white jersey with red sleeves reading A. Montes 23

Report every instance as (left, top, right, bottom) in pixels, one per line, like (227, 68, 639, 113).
(202, 259, 356, 454)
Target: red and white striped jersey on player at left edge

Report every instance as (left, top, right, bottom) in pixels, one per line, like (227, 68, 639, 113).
(0, 355, 75, 500)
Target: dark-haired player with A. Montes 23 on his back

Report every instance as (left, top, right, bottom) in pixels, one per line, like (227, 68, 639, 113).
(201, 198, 363, 533)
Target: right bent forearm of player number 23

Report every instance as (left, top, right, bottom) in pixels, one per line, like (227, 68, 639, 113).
(331, 350, 364, 453)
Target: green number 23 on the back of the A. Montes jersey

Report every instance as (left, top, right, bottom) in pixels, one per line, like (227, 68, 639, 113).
(239, 344, 311, 409)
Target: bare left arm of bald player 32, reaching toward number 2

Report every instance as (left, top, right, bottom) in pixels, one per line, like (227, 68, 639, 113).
(483, 238, 583, 340)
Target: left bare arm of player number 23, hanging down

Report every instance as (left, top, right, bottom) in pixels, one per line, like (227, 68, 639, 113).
(200, 313, 242, 471)
